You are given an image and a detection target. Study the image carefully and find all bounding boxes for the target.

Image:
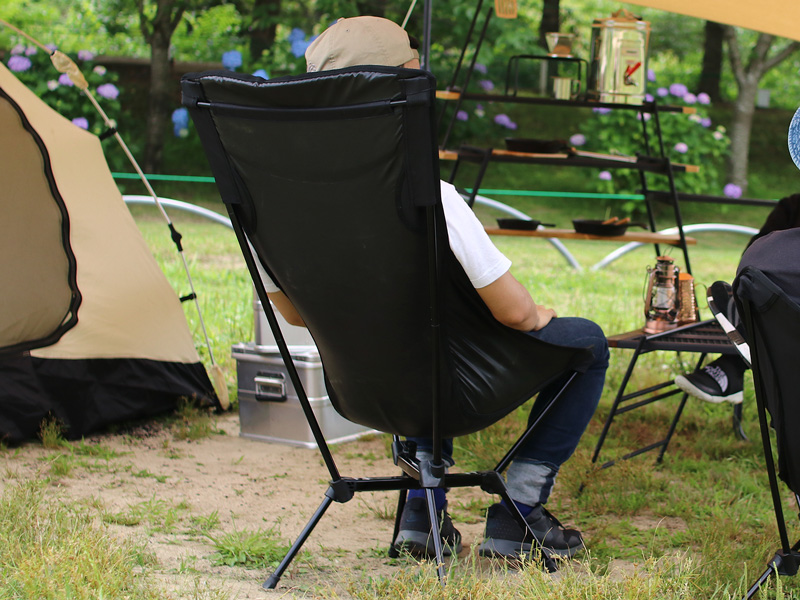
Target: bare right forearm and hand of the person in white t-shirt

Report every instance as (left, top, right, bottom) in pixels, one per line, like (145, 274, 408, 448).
(477, 271, 557, 331)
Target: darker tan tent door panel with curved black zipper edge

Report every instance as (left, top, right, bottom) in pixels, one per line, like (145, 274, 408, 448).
(0, 88, 80, 349)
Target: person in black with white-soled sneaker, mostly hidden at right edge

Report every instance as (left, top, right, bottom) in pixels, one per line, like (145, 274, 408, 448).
(675, 194, 800, 404)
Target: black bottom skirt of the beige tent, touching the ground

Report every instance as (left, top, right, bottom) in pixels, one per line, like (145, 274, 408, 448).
(0, 356, 218, 443)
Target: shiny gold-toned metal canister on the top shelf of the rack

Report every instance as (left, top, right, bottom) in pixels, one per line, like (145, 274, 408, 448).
(587, 9, 650, 104)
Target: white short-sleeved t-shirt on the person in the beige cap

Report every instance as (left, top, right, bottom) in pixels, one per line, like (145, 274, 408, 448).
(258, 181, 511, 294)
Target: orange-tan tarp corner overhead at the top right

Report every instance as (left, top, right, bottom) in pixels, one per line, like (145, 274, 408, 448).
(631, 0, 800, 40)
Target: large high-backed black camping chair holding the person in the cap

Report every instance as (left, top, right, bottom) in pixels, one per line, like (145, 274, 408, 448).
(182, 67, 591, 588)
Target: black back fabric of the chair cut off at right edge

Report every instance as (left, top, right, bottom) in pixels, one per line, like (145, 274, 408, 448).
(733, 266, 800, 493)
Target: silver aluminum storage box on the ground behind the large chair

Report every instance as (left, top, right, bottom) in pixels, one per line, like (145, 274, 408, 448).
(232, 342, 374, 448)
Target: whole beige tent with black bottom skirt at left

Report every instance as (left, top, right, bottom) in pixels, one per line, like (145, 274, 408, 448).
(0, 65, 216, 441)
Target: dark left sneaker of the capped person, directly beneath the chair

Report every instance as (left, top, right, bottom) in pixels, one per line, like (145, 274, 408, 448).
(392, 498, 461, 558)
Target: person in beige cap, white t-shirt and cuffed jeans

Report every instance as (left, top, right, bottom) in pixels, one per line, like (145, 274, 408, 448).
(267, 17, 608, 557)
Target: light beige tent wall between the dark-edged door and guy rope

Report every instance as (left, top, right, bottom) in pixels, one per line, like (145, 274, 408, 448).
(0, 66, 199, 363)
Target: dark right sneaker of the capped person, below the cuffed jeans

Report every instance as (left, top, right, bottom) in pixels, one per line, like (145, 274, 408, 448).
(478, 504, 583, 560)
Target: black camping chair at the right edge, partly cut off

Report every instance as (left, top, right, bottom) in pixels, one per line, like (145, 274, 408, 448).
(720, 266, 800, 599)
